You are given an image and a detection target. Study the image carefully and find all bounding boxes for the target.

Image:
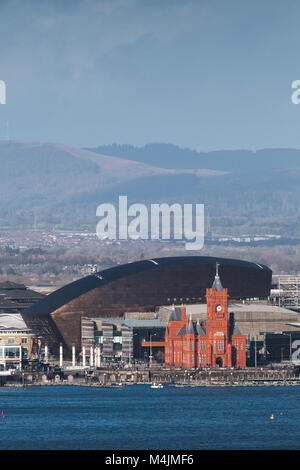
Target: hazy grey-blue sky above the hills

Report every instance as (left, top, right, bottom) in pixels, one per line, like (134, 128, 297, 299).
(0, 0, 300, 151)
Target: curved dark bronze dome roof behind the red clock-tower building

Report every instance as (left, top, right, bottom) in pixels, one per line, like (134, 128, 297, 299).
(22, 256, 272, 355)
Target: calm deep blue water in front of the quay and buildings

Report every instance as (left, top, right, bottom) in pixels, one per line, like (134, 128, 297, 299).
(0, 385, 300, 450)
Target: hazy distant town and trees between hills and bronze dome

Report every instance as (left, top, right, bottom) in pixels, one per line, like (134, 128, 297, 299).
(0, 229, 300, 286)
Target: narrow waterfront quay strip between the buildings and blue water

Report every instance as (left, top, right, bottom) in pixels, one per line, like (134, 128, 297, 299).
(0, 368, 300, 389)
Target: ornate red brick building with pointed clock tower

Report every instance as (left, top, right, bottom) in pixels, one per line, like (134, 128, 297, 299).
(165, 265, 246, 368)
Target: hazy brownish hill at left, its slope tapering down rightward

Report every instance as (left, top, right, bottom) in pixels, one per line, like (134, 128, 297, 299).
(0, 141, 224, 211)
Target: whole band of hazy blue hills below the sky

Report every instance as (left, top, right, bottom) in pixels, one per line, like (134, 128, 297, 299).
(0, 141, 300, 236)
